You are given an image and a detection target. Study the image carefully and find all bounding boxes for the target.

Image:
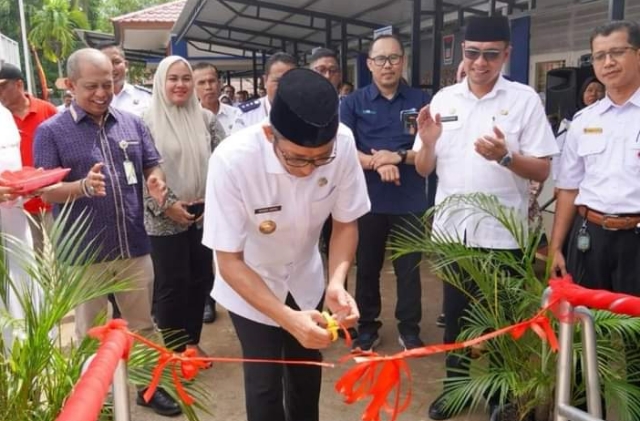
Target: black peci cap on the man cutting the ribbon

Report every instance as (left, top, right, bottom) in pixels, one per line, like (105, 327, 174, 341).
(269, 69, 340, 148)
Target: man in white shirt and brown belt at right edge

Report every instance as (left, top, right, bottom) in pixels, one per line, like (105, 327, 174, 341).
(549, 21, 640, 404)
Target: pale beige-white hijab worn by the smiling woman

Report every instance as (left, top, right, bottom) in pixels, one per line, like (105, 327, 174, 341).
(143, 56, 211, 202)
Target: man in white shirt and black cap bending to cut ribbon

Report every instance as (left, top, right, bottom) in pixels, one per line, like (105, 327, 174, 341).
(203, 69, 370, 421)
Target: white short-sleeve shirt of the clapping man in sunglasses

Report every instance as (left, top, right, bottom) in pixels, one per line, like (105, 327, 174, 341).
(414, 77, 558, 249)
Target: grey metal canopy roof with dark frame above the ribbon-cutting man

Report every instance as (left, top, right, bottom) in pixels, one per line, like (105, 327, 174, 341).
(173, 0, 508, 57)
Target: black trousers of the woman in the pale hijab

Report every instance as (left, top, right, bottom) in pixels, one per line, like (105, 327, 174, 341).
(149, 225, 213, 351)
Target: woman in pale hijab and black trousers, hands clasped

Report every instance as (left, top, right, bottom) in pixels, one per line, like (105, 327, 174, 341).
(143, 56, 224, 356)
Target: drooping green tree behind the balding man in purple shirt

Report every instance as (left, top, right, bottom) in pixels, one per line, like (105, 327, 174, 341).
(28, 0, 89, 77)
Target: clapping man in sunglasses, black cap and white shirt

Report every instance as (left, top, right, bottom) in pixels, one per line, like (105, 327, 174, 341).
(414, 16, 557, 420)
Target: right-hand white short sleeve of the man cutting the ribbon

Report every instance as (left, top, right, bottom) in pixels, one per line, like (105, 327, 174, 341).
(331, 130, 371, 222)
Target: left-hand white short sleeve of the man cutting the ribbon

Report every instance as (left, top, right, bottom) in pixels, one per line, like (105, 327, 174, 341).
(202, 151, 247, 253)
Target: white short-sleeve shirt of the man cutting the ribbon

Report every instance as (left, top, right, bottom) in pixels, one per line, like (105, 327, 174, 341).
(202, 124, 371, 326)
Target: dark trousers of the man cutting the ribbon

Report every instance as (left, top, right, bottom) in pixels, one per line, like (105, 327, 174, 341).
(229, 295, 322, 421)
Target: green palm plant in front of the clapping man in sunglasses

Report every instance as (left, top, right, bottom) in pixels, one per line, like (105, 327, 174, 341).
(390, 194, 640, 421)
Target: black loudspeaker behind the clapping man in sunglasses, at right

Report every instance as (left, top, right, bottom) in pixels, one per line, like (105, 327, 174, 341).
(545, 66, 594, 121)
